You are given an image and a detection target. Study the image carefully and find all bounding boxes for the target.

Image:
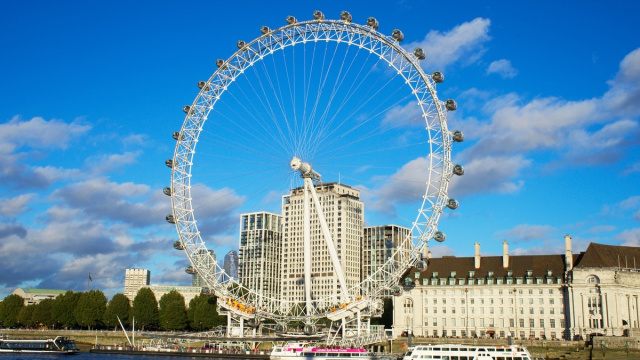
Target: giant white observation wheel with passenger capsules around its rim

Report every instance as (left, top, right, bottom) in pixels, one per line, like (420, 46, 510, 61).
(164, 11, 464, 324)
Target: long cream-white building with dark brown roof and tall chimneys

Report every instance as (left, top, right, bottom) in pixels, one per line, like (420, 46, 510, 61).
(394, 236, 640, 339)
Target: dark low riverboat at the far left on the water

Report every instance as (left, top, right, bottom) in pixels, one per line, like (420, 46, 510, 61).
(0, 336, 79, 355)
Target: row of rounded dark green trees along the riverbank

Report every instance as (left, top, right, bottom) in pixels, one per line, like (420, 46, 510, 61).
(0, 288, 226, 330)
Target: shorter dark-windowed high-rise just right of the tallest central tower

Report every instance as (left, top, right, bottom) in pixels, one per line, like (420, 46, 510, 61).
(362, 225, 412, 280)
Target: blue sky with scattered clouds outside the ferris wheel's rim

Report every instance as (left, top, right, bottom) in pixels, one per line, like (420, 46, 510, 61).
(0, 1, 640, 297)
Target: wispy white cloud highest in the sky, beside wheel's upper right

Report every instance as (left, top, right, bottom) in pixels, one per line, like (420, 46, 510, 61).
(404, 18, 491, 70)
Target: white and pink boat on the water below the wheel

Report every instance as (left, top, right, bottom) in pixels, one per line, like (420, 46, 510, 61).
(269, 343, 379, 360)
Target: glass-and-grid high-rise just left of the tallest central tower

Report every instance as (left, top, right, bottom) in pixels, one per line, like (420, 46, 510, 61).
(238, 212, 282, 298)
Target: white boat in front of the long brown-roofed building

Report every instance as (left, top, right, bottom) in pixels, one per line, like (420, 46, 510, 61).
(403, 344, 532, 360)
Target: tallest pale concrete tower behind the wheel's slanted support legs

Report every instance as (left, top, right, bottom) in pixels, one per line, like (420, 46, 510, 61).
(281, 183, 364, 309)
